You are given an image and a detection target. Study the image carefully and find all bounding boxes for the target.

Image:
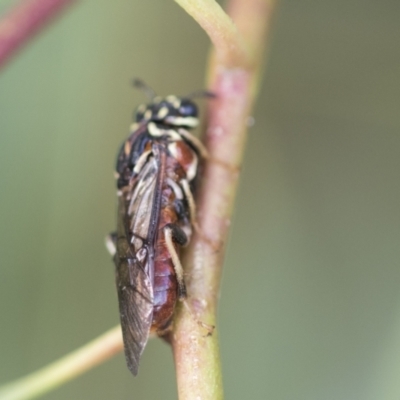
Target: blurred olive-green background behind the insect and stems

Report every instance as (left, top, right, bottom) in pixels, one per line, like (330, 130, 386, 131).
(0, 0, 400, 400)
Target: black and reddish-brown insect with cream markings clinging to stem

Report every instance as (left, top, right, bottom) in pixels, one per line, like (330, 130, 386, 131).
(108, 81, 212, 375)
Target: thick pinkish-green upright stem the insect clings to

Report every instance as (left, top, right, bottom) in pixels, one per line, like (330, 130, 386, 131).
(171, 0, 275, 400)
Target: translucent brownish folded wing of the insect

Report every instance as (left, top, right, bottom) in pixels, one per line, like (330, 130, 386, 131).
(114, 156, 160, 375)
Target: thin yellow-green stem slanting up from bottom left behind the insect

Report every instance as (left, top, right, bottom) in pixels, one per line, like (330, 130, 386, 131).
(0, 325, 123, 400)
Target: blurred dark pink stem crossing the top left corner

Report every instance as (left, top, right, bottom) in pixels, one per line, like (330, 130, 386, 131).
(0, 0, 75, 68)
